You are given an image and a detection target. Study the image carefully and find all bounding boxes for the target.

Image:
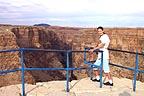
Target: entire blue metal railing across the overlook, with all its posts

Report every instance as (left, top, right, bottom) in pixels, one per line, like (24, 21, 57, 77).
(0, 48, 144, 96)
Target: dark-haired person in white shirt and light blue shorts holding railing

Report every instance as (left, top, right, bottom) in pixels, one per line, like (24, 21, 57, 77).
(89, 26, 113, 86)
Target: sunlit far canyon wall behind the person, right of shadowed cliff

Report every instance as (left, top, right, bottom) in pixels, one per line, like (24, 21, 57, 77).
(48, 26, 144, 81)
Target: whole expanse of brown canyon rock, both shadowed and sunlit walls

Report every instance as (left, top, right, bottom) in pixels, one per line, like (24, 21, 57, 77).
(0, 26, 144, 86)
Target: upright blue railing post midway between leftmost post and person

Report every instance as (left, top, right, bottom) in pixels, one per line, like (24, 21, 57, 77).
(66, 51, 69, 92)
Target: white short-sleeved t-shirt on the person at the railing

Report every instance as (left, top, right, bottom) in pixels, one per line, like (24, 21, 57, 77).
(98, 34, 110, 59)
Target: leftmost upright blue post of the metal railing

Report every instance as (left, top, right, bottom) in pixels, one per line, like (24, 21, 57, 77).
(20, 49, 25, 96)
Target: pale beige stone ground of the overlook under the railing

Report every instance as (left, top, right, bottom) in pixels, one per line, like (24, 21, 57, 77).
(0, 77, 144, 96)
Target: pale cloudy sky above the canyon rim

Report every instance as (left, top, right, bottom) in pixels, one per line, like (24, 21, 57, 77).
(0, 0, 144, 27)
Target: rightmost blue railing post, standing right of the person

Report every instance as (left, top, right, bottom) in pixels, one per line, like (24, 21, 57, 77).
(133, 53, 138, 91)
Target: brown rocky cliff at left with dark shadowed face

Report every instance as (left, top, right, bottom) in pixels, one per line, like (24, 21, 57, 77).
(0, 26, 71, 86)
